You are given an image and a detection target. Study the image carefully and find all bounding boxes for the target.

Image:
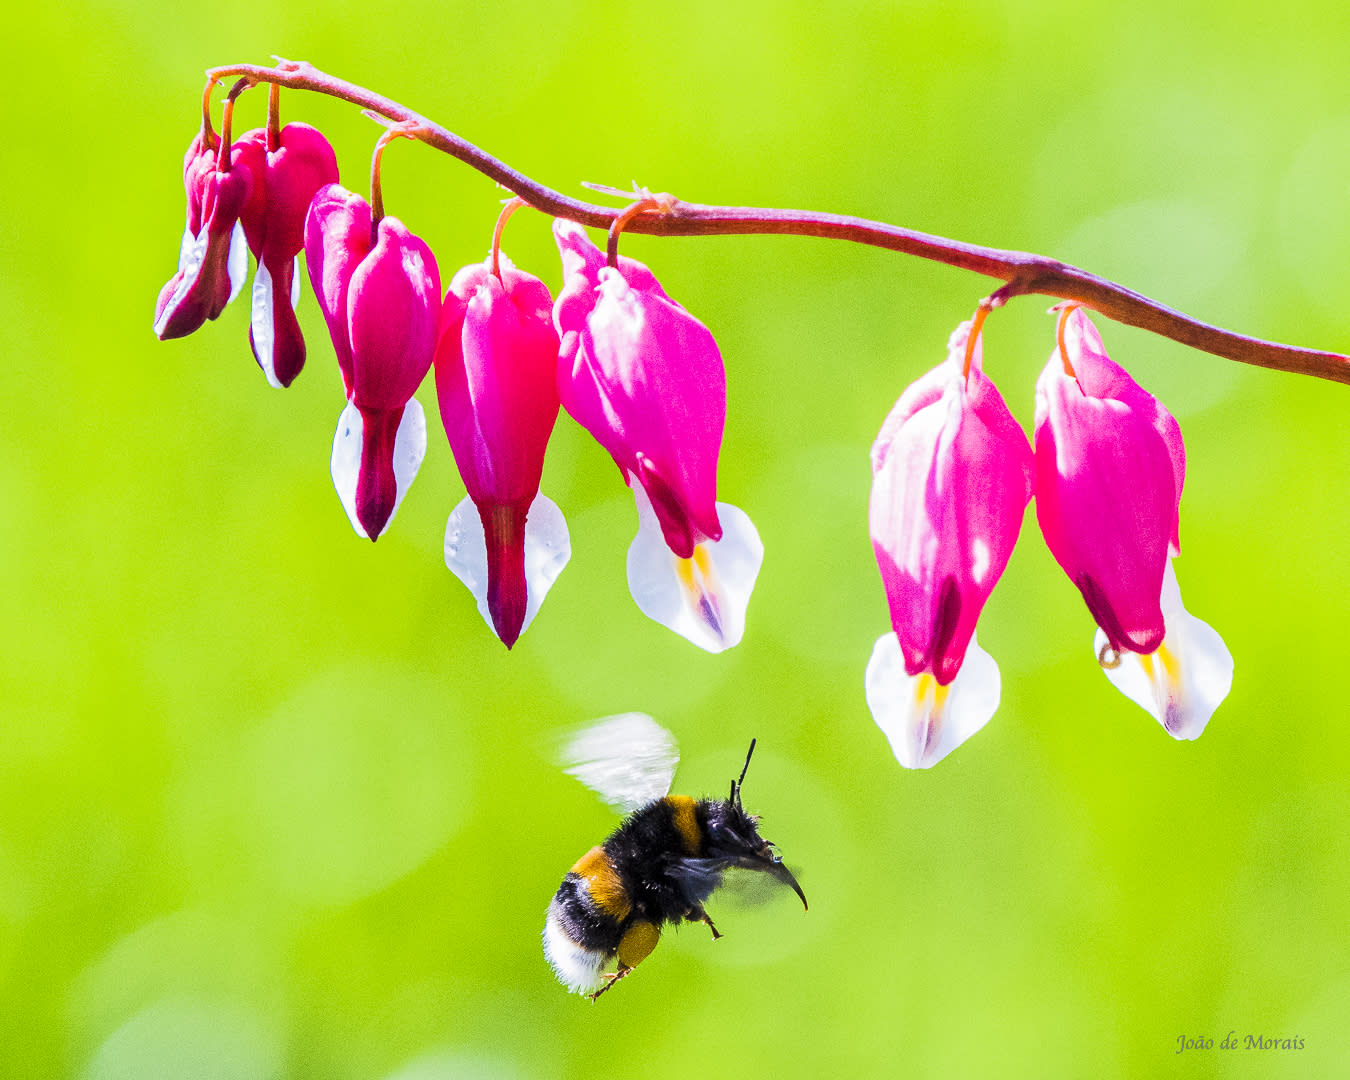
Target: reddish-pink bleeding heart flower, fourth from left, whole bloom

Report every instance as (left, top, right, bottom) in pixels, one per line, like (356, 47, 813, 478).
(436, 255, 571, 648)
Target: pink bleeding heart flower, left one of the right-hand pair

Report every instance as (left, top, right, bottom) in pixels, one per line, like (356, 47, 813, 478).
(865, 323, 1031, 768)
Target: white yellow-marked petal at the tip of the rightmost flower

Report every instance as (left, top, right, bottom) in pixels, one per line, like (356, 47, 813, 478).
(1092, 559, 1233, 740)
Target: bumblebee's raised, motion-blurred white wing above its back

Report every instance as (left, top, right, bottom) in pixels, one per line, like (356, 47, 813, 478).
(562, 713, 679, 814)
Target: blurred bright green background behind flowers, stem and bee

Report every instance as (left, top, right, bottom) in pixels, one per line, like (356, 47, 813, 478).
(0, 0, 1350, 1080)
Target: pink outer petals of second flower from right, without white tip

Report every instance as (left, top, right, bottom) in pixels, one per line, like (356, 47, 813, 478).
(869, 325, 1031, 686)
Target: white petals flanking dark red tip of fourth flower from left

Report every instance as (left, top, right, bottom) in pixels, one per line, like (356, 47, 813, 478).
(446, 494, 572, 633)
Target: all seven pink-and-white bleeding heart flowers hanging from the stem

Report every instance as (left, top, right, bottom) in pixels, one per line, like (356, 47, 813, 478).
(154, 99, 1233, 739)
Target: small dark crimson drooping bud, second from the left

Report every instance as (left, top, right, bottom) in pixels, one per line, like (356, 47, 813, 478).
(239, 123, 338, 387)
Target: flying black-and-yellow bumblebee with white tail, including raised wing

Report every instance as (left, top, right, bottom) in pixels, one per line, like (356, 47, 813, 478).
(544, 713, 806, 1000)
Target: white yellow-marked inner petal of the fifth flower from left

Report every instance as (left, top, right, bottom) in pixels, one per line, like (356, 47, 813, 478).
(628, 483, 764, 652)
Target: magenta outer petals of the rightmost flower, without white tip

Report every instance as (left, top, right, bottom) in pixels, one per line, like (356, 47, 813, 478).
(1035, 312, 1185, 652)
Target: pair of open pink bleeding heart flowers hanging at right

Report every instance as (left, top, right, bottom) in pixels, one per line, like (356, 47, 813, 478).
(865, 308, 1233, 768)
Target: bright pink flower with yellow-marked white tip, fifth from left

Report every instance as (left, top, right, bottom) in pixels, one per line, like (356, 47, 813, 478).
(554, 220, 764, 652)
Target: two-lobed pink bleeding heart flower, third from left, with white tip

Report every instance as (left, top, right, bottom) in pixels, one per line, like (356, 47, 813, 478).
(305, 184, 440, 540)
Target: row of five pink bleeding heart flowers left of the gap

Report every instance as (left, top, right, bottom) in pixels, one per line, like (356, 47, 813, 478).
(154, 124, 763, 652)
